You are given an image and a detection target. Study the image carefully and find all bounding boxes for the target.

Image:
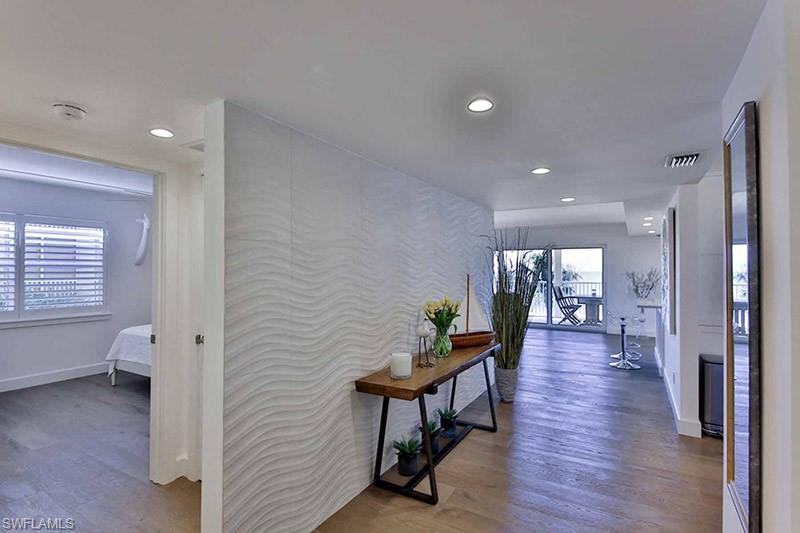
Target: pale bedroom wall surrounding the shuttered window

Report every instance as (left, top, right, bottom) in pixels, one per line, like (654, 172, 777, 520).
(0, 178, 153, 391)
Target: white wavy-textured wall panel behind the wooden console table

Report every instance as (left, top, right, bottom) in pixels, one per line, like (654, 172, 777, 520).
(223, 103, 493, 532)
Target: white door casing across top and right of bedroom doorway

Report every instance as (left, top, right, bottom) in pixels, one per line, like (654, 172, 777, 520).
(0, 118, 203, 484)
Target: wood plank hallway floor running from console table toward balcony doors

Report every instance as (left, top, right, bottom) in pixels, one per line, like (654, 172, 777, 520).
(317, 330, 722, 533)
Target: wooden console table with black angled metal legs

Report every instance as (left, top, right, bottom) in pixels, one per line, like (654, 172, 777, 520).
(356, 343, 500, 505)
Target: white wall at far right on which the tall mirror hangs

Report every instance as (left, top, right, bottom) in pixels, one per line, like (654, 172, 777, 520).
(721, 0, 800, 532)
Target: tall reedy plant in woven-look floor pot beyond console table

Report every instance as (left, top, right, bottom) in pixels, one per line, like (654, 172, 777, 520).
(490, 230, 550, 403)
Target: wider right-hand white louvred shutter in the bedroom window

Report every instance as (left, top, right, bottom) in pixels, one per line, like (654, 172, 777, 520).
(23, 222, 106, 311)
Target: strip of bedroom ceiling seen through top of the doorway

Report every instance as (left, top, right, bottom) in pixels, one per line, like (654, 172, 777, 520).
(0, 144, 153, 196)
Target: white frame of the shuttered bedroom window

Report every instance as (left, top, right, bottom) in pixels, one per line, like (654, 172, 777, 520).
(0, 213, 111, 329)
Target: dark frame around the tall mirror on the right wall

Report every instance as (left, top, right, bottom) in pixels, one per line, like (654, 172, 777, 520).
(723, 102, 761, 533)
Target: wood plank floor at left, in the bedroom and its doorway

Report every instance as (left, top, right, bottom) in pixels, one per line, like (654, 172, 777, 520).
(0, 373, 200, 533)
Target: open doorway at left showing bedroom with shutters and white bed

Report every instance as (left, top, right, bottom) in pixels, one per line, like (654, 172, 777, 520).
(0, 144, 199, 531)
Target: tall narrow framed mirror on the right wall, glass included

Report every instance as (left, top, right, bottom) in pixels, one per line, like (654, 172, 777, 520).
(723, 102, 761, 532)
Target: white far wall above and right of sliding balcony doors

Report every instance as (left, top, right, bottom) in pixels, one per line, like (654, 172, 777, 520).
(496, 223, 660, 337)
